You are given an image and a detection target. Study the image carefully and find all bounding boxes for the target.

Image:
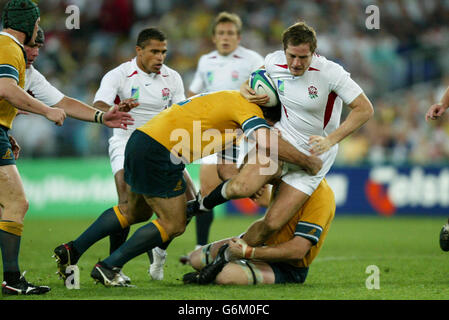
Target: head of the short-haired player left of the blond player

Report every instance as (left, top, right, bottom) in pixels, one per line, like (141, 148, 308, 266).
(136, 28, 167, 73)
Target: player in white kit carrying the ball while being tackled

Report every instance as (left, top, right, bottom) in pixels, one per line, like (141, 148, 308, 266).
(195, 22, 373, 264)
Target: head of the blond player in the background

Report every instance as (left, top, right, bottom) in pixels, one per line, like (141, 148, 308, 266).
(212, 12, 242, 56)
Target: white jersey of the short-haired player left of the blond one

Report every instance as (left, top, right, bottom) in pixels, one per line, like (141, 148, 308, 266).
(94, 58, 185, 136)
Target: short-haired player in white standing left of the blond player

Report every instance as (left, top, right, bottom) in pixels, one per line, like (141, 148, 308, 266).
(88, 28, 195, 280)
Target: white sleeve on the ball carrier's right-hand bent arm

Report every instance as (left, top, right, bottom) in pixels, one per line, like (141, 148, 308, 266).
(327, 62, 363, 104)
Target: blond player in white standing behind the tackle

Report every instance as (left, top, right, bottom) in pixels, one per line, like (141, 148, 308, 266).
(188, 12, 269, 252)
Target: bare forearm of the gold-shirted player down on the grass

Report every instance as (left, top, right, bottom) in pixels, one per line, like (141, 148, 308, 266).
(229, 236, 313, 262)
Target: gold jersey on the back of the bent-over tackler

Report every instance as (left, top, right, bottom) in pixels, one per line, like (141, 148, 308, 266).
(137, 90, 270, 162)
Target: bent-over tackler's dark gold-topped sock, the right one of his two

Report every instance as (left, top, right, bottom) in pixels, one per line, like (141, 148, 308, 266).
(102, 220, 168, 268)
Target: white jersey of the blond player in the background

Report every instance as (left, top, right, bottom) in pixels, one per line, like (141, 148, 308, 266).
(189, 46, 264, 93)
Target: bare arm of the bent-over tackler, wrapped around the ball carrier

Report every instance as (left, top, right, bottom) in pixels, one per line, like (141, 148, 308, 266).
(254, 127, 323, 175)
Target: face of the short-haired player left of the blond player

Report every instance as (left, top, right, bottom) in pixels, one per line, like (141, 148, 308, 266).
(136, 39, 167, 73)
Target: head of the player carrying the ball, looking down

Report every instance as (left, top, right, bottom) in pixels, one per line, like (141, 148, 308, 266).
(282, 22, 317, 76)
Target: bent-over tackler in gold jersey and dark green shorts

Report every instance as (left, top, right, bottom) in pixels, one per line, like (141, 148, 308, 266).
(54, 91, 322, 286)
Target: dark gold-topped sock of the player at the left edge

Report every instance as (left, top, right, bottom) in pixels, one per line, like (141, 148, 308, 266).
(0, 220, 23, 284)
